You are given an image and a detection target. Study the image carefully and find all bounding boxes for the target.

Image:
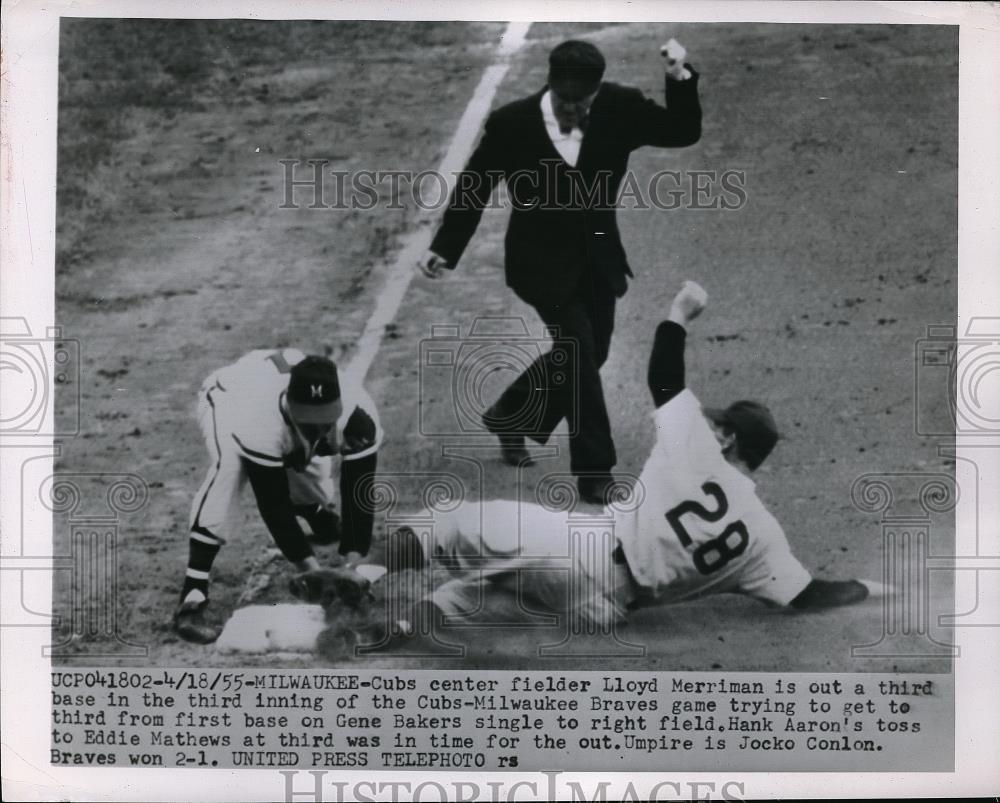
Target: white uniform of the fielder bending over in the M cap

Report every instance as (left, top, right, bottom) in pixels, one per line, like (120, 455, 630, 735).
(191, 349, 382, 543)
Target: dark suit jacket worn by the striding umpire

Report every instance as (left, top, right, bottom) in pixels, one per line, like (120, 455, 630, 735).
(431, 74, 701, 307)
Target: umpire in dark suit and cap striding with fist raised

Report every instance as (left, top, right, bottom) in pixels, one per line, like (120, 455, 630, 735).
(419, 41, 701, 504)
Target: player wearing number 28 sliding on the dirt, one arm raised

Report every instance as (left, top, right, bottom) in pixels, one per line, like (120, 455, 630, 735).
(292, 282, 883, 648)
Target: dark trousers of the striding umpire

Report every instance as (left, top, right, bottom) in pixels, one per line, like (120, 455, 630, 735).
(497, 273, 617, 475)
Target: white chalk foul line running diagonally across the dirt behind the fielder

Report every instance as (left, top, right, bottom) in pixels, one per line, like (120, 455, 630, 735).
(344, 22, 531, 383)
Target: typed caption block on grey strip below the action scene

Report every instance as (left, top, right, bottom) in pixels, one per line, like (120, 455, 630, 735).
(51, 669, 954, 772)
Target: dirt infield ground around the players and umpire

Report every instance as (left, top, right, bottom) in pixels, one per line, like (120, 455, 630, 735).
(54, 19, 958, 672)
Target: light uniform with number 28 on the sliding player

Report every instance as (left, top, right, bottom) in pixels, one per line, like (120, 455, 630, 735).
(423, 390, 811, 626)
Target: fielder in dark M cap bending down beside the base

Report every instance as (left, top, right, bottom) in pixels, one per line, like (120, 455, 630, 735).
(173, 349, 382, 644)
